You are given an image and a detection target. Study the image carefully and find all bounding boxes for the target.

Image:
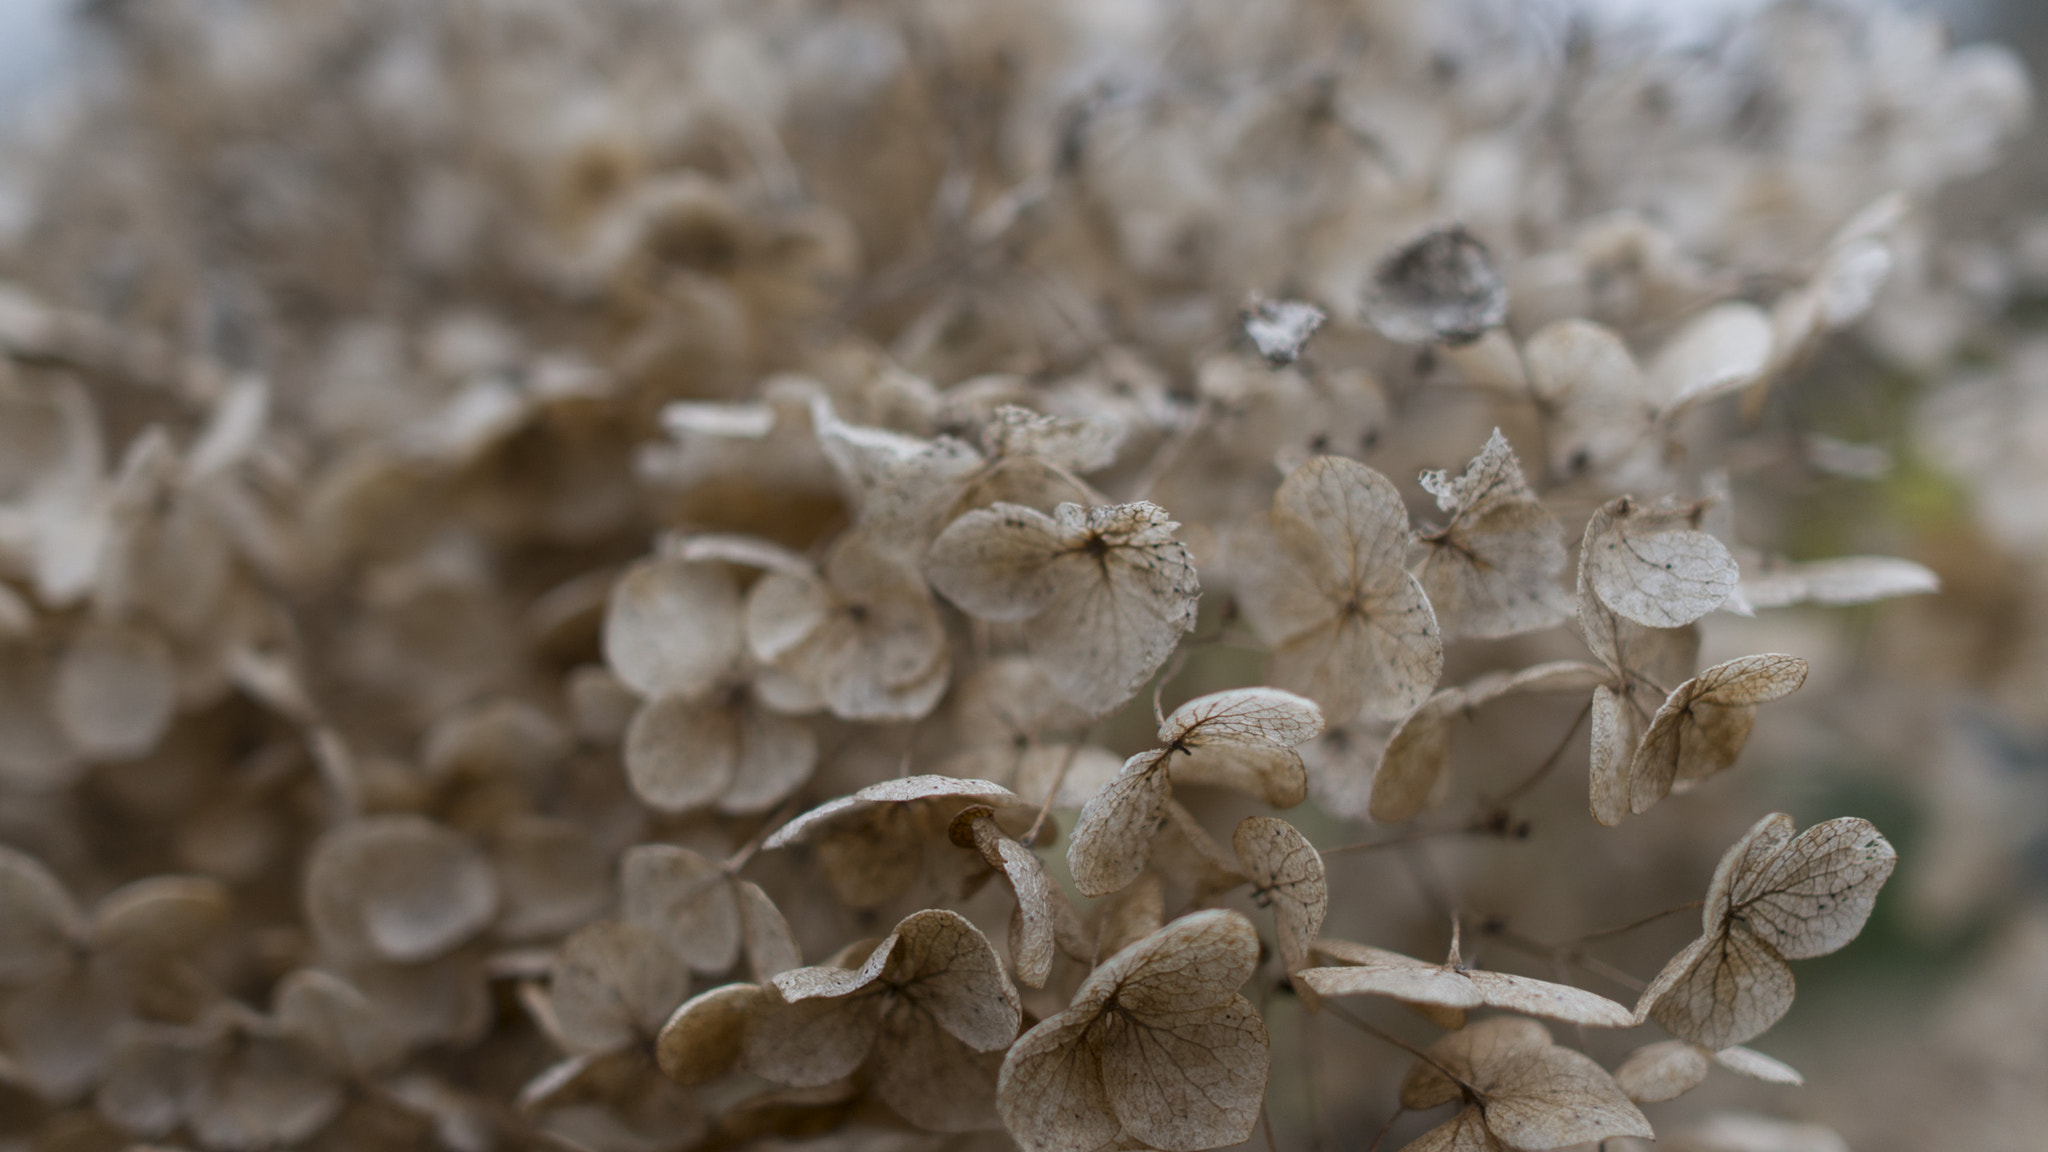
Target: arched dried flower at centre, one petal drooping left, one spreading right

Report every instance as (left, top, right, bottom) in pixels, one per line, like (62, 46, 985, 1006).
(1067, 689, 1323, 896)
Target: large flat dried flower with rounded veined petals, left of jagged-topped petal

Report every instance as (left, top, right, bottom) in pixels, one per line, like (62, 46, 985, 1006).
(1239, 457, 1444, 724)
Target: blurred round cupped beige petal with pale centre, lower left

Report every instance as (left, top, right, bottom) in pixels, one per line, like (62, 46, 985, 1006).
(305, 816, 498, 963)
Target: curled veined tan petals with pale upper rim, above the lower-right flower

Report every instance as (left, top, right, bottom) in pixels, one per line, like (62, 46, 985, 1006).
(1628, 654, 1806, 816)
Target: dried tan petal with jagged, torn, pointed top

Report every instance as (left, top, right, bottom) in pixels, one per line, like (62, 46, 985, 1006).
(1415, 428, 1571, 637)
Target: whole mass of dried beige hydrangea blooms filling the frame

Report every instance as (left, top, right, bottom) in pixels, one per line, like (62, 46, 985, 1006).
(0, 0, 2028, 1152)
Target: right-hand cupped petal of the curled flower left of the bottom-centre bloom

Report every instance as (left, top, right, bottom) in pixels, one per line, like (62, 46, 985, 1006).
(883, 908, 1022, 1052)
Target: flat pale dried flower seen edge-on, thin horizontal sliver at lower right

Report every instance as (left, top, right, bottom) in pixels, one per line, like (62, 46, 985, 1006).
(1296, 939, 1634, 1027)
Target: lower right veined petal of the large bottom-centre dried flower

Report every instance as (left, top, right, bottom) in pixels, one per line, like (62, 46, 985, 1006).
(1098, 988, 1272, 1152)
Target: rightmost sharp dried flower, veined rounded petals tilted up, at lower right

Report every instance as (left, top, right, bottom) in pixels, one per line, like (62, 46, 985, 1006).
(1636, 812, 1898, 1052)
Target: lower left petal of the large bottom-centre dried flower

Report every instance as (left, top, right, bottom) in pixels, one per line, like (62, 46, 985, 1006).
(995, 1006, 1122, 1152)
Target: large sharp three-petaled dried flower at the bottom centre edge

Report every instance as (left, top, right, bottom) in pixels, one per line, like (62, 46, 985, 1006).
(997, 910, 1272, 1152)
